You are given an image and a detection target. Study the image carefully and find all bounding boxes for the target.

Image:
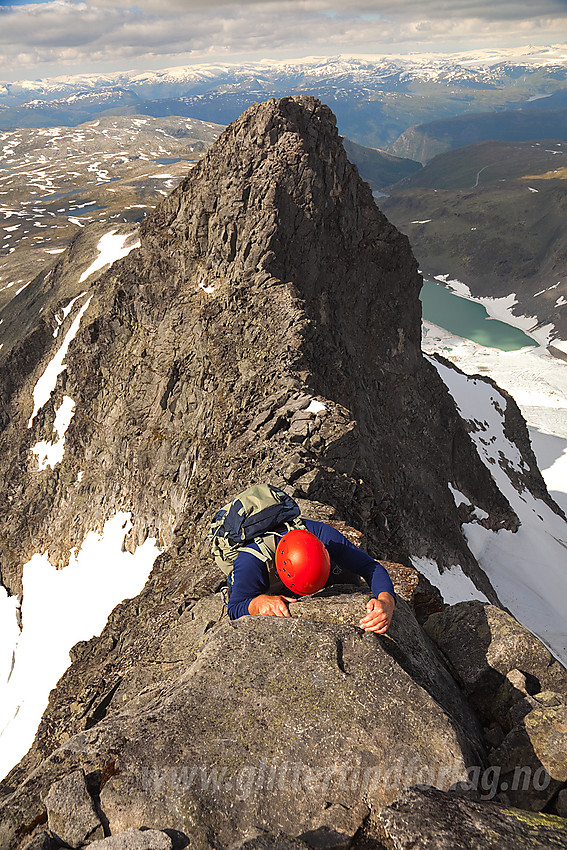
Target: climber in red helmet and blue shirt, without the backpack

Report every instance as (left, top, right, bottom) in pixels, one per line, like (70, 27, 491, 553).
(228, 519, 396, 634)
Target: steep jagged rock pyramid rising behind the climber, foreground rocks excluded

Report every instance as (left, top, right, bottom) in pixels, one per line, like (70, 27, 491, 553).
(1, 98, 517, 599)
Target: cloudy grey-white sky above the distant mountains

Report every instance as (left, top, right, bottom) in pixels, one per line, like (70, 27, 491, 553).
(0, 0, 567, 80)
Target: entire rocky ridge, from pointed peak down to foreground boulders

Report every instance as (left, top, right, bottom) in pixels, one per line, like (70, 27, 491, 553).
(0, 97, 567, 850)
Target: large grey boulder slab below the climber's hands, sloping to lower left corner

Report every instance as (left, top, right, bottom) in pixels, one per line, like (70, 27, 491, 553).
(0, 588, 488, 850)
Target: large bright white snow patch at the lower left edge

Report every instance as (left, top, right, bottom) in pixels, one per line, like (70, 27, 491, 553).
(0, 513, 159, 777)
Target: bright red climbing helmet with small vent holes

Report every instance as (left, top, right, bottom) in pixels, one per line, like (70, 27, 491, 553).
(276, 528, 331, 596)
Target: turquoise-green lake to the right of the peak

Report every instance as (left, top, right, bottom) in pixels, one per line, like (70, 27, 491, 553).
(420, 280, 537, 351)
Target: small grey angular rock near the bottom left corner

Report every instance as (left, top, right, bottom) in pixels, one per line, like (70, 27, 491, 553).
(44, 770, 103, 847)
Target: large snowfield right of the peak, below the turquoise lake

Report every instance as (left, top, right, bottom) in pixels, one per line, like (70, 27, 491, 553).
(422, 323, 567, 664)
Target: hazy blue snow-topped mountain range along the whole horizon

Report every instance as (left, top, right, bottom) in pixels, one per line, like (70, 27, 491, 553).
(0, 46, 567, 148)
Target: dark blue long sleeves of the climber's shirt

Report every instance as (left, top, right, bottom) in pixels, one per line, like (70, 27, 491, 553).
(228, 519, 395, 620)
